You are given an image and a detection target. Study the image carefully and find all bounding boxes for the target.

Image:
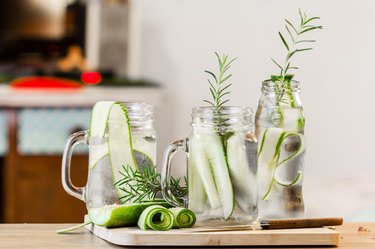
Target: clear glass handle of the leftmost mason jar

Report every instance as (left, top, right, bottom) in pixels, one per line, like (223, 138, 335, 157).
(61, 131, 88, 201)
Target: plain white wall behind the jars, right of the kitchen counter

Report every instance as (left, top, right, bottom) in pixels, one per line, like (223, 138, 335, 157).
(132, 0, 375, 221)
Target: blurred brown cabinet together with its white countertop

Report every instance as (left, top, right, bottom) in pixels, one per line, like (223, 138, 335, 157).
(0, 87, 162, 223)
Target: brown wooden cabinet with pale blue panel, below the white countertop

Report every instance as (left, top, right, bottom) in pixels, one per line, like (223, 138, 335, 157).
(3, 108, 89, 223)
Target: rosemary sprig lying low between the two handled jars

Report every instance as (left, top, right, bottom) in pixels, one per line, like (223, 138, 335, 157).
(115, 165, 187, 203)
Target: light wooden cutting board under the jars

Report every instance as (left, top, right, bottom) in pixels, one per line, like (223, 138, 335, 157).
(86, 224, 340, 246)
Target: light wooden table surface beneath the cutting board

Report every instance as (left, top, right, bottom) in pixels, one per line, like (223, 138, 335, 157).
(0, 223, 375, 249)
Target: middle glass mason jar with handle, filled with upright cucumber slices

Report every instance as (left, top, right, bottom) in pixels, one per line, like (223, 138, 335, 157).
(161, 107, 257, 224)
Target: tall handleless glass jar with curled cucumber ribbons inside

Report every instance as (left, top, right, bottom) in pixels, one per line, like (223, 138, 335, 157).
(255, 80, 305, 218)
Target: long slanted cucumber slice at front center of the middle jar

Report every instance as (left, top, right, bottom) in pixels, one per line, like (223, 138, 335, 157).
(201, 133, 234, 220)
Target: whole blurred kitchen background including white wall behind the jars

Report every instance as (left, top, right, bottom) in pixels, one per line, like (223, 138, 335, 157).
(0, 0, 375, 222)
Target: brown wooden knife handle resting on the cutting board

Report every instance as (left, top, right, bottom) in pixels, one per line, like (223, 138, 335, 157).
(260, 217, 343, 229)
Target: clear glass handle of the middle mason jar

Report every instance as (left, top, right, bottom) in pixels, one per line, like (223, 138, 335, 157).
(161, 139, 188, 206)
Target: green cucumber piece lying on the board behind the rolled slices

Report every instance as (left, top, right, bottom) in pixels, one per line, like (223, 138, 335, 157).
(88, 201, 170, 228)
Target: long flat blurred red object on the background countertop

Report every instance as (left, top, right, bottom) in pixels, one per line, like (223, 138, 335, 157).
(10, 76, 82, 90)
